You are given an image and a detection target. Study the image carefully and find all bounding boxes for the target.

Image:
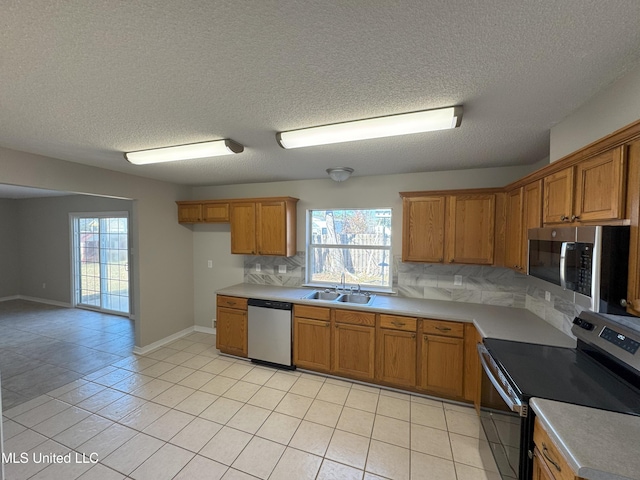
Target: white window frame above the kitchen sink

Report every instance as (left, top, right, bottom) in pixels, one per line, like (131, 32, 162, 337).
(303, 207, 393, 293)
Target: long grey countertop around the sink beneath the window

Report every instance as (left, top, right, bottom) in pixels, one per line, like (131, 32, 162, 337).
(216, 283, 576, 348)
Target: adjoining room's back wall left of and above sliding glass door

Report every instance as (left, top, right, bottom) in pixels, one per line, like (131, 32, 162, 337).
(16, 195, 133, 304)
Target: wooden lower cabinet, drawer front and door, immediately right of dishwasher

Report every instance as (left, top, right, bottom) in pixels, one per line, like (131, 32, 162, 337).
(293, 305, 331, 373)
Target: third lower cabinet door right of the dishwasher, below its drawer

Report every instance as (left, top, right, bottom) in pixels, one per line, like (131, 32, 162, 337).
(376, 328, 417, 388)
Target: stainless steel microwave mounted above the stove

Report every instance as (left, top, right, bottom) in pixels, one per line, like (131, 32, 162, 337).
(527, 226, 629, 315)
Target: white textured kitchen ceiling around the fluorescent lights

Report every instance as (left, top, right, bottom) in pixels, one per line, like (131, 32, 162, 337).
(0, 0, 640, 185)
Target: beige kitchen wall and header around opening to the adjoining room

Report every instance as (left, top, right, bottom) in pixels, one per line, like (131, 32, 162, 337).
(0, 148, 194, 347)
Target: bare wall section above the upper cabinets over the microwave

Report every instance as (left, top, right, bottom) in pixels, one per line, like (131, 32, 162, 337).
(550, 60, 640, 162)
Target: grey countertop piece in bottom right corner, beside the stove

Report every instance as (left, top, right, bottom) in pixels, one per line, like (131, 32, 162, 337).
(530, 398, 640, 480)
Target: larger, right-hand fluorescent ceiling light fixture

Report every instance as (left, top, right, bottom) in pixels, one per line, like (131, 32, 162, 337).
(276, 106, 462, 148)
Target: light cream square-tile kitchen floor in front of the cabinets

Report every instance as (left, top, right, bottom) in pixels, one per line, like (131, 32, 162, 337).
(4, 304, 499, 480)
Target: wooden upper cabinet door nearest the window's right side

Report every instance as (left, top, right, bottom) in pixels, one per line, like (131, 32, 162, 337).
(402, 196, 445, 263)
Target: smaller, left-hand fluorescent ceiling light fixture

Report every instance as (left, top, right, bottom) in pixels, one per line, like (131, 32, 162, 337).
(124, 139, 244, 165)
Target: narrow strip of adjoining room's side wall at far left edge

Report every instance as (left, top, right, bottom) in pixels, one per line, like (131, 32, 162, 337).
(0, 198, 20, 299)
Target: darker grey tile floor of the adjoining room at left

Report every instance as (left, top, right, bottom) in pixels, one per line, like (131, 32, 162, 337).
(0, 300, 134, 409)
